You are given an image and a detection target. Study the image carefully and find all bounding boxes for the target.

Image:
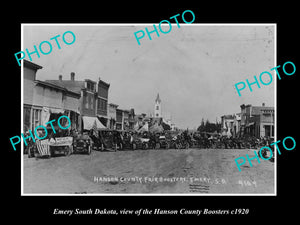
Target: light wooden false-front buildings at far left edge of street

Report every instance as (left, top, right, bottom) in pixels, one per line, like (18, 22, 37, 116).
(23, 60, 80, 132)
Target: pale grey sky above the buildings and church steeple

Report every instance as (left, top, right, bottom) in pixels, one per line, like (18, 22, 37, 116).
(21, 23, 276, 129)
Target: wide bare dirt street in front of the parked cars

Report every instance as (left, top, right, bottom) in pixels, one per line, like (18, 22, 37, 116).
(23, 149, 275, 194)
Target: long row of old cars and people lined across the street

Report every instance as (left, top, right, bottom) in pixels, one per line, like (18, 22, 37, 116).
(24, 128, 271, 157)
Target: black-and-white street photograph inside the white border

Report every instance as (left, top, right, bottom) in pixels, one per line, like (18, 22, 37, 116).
(21, 25, 276, 195)
